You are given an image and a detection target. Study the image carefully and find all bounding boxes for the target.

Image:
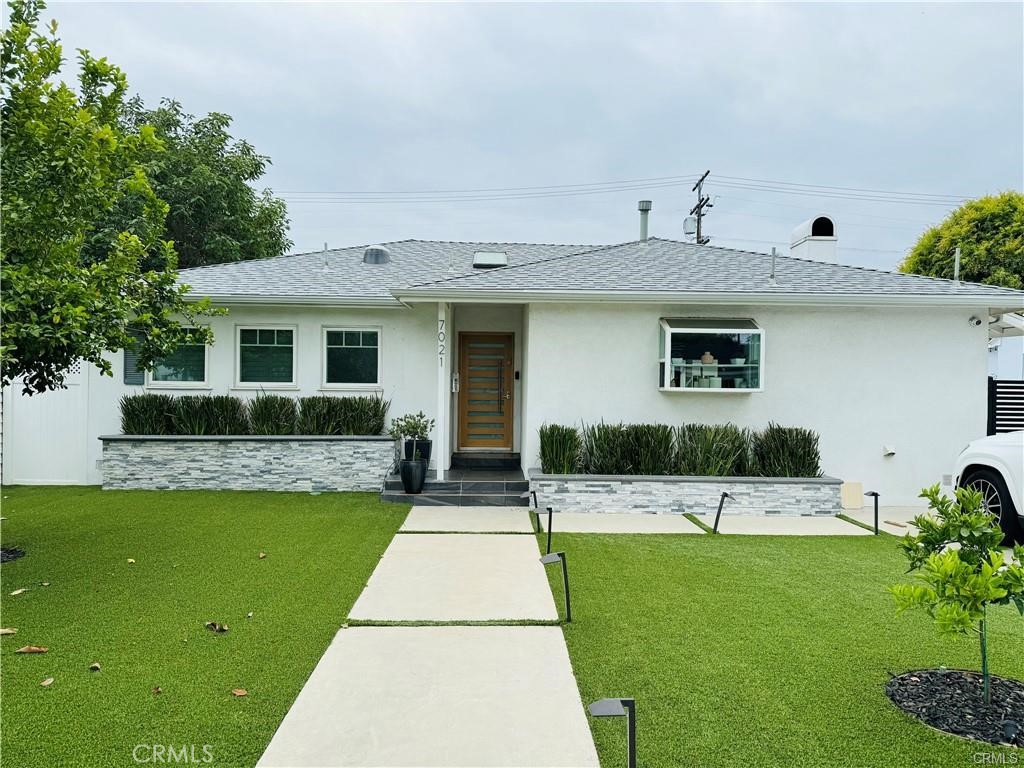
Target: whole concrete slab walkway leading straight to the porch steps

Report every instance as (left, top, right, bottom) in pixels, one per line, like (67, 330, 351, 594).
(257, 507, 598, 768)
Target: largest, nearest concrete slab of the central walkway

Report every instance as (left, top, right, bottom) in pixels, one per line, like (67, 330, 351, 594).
(258, 626, 598, 768)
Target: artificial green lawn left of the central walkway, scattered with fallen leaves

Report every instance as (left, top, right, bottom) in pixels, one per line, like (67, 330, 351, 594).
(0, 487, 409, 768)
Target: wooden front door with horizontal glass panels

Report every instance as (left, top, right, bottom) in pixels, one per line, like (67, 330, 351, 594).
(459, 333, 515, 451)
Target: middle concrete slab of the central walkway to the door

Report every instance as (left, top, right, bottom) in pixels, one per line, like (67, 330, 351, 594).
(349, 536, 558, 622)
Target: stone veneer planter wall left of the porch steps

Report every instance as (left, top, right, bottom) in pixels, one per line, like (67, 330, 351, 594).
(99, 434, 394, 492)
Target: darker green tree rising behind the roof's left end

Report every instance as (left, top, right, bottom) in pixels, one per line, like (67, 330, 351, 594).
(87, 97, 292, 268)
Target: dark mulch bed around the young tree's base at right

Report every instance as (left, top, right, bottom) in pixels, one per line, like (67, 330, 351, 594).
(886, 670, 1024, 746)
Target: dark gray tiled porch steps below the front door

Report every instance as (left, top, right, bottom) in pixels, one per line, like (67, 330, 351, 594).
(381, 468, 529, 507)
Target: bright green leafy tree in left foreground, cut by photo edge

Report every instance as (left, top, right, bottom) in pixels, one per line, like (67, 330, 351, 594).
(0, 0, 210, 394)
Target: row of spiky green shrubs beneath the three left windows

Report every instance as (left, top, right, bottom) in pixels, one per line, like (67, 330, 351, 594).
(121, 393, 391, 435)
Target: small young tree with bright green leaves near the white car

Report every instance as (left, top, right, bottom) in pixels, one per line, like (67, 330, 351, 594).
(889, 484, 1024, 703)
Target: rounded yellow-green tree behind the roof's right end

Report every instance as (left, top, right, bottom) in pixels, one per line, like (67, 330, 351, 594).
(899, 191, 1024, 289)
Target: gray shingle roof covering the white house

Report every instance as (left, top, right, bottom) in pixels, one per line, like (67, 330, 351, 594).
(180, 238, 1024, 306)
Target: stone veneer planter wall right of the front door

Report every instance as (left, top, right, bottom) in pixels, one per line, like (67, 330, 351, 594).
(529, 469, 842, 515)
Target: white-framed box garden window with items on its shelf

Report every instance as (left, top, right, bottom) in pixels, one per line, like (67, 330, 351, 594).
(658, 317, 764, 392)
